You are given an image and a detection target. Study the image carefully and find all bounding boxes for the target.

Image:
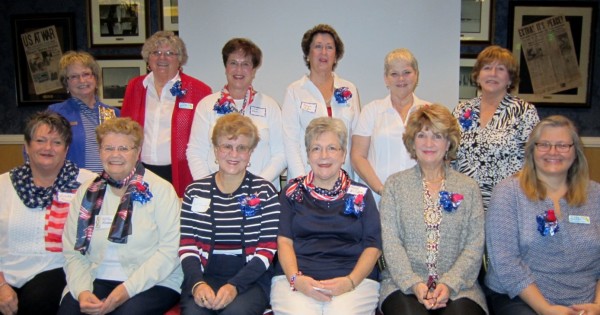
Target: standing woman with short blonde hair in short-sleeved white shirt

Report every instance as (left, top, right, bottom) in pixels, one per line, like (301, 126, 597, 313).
(350, 48, 428, 201)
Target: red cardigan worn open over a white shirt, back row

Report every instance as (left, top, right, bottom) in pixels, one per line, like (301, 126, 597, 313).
(121, 72, 212, 197)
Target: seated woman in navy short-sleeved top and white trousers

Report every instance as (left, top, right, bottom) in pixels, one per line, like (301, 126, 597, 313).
(271, 117, 381, 315)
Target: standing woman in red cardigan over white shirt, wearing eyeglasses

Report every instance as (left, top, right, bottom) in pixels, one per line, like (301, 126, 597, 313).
(121, 31, 211, 197)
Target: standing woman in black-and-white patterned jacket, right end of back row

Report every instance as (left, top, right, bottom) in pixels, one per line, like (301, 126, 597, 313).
(453, 46, 539, 209)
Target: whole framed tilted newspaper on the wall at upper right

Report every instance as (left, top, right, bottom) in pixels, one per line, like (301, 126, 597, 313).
(509, 1, 598, 107)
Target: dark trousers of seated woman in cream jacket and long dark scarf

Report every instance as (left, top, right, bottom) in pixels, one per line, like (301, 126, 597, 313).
(58, 279, 179, 315)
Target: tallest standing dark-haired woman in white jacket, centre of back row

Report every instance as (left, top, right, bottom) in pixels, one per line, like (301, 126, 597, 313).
(281, 24, 360, 179)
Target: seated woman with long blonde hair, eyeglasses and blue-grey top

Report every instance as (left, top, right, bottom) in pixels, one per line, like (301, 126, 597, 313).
(486, 116, 600, 315)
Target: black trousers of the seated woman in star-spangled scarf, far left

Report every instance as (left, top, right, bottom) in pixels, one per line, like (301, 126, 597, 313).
(13, 268, 67, 315)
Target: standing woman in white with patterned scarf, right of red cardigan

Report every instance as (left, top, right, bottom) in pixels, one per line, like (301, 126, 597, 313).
(187, 38, 285, 191)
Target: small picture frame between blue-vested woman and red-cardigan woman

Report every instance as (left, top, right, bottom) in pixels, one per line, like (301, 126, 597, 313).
(97, 57, 147, 107)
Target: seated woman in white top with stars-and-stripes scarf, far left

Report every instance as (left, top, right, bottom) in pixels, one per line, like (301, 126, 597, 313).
(0, 112, 96, 314)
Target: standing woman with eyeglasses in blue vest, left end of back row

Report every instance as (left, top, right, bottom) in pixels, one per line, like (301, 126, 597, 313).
(48, 51, 120, 173)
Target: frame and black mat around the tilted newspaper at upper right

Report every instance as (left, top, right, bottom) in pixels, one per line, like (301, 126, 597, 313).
(508, 1, 598, 107)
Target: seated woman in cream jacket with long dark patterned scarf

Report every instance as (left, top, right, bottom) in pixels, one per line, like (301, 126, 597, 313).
(59, 118, 183, 314)
